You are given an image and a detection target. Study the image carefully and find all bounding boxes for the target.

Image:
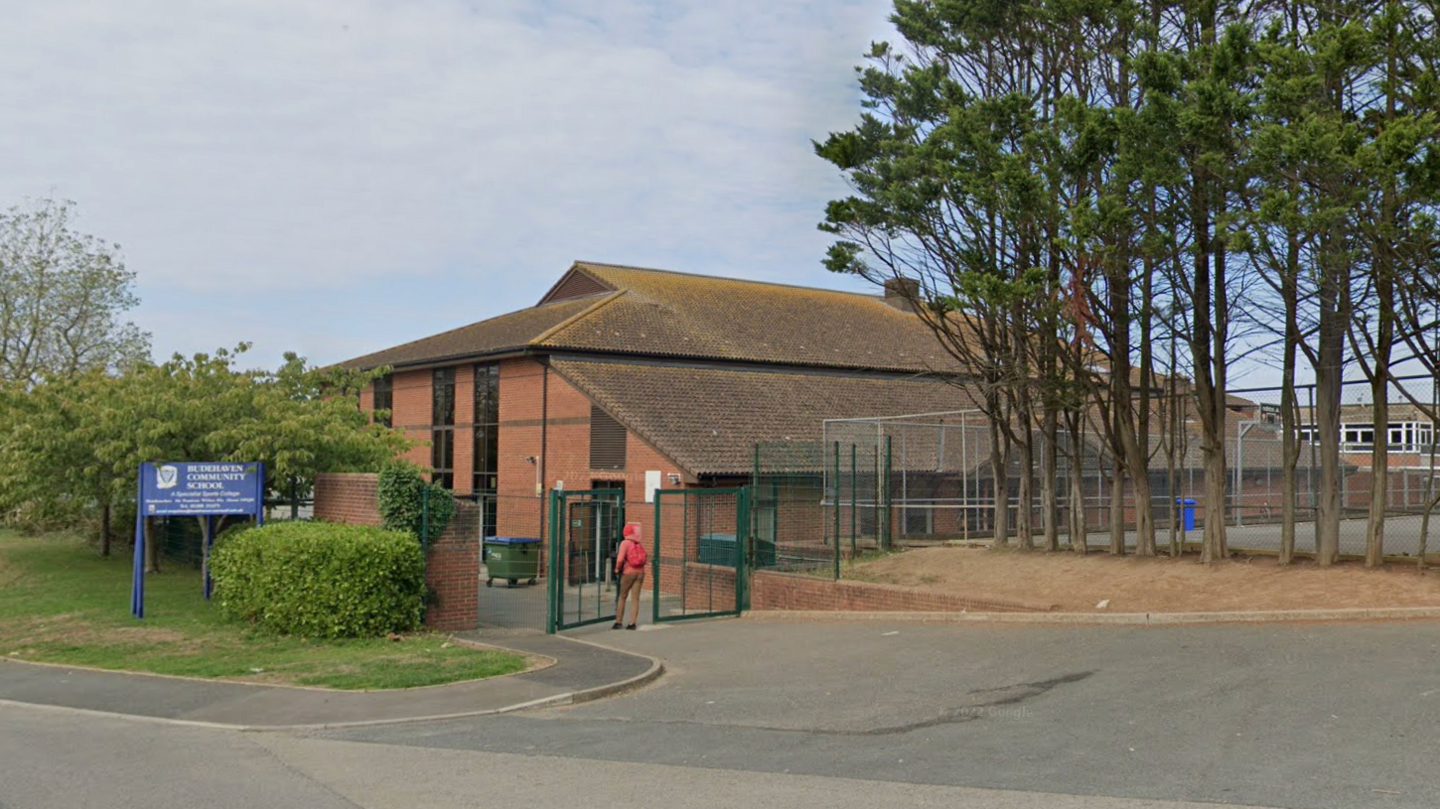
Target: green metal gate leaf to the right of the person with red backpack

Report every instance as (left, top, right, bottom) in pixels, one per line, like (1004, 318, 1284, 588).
(651, 488, 750, 623)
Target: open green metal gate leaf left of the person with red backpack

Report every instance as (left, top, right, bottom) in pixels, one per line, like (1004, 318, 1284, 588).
(546, 489, 625, 635)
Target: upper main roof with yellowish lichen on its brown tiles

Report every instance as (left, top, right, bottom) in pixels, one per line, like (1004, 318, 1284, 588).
(343, 262, 956, 371)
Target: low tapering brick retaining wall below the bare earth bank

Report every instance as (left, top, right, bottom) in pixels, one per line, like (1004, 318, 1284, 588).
(750, 570, 1054, 612)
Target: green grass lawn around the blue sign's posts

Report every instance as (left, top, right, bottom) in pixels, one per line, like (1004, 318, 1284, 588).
(0, 531, 527, 690)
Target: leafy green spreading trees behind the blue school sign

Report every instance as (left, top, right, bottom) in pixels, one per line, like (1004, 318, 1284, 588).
(0, 344, 410, 570)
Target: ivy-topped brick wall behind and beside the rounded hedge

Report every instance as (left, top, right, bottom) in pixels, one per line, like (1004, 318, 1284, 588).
(315, 474, 480, 632)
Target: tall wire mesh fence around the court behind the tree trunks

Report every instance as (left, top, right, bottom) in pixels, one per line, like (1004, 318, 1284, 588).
(753, 377, 1440, 577)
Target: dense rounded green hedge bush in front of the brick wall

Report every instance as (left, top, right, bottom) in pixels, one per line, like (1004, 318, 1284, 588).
(210, 523, 425, 638)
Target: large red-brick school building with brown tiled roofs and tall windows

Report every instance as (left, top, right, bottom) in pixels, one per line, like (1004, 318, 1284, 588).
(331, 262, 971, 549)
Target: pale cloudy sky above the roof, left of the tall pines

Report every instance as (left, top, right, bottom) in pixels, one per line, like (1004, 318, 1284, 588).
(0, 0, 894, 367)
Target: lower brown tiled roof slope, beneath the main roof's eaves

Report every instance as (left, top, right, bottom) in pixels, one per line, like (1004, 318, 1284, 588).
(550, 360, 973, 475)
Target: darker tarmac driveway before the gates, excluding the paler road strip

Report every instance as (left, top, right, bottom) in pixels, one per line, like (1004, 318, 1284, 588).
(324, 619, 1440, 809)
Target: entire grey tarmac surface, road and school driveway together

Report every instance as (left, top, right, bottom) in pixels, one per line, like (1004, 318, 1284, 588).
(0, 620, 1440, 809)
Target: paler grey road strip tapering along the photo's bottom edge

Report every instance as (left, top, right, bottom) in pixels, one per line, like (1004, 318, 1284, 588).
(0, 705, 1290, 809)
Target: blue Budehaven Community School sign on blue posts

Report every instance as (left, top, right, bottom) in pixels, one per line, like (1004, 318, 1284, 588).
(130, 464, 265, 618)
